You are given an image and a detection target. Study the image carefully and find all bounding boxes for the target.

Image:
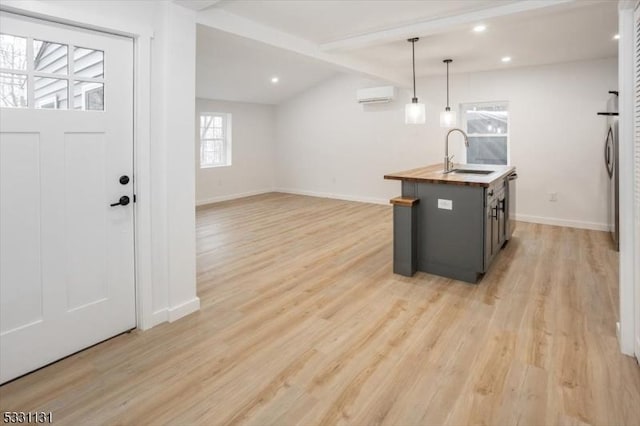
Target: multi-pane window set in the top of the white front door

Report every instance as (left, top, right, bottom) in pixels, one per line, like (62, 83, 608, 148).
(0, 34, 104, 111)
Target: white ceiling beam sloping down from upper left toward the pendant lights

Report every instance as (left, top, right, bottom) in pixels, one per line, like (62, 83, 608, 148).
(196, 8, 410, 87)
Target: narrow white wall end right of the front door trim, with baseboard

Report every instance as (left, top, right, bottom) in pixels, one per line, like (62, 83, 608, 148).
(159, 2, 200, 321)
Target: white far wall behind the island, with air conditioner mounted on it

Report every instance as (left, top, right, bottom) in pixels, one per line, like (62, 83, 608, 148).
(276, 58, 617, 229)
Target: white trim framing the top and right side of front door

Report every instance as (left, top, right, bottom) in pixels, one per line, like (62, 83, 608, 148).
(0, 0, 158, 330)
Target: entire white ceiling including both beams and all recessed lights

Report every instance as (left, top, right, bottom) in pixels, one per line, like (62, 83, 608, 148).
(191, 0, 617, 103)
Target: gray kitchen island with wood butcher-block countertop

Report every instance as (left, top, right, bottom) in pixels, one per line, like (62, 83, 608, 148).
(384, 164, 516, 283)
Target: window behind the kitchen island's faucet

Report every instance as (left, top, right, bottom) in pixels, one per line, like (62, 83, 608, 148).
(460, 102, 509, 164)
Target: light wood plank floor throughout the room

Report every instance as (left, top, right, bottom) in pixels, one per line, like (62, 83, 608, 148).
(0, 194, 640, 426)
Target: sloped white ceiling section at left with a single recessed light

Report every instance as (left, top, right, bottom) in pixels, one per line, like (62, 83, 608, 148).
(196, 25, 337, 104)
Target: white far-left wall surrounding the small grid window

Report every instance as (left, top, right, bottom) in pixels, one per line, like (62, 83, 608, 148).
(195, 98, 276, 205)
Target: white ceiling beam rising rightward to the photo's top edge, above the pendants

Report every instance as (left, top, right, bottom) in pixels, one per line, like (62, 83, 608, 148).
(320, 0, 575, 52)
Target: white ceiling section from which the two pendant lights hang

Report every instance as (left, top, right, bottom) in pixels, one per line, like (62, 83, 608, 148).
(350, 1, 618, 79)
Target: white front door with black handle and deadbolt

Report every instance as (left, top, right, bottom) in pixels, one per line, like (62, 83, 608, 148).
(0, 13, 136, 383)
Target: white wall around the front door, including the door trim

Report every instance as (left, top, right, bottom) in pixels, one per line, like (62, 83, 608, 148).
(2, 0, 199, 328)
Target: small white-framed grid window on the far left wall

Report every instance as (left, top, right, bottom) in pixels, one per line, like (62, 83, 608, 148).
(200, 112, 231, 168)
